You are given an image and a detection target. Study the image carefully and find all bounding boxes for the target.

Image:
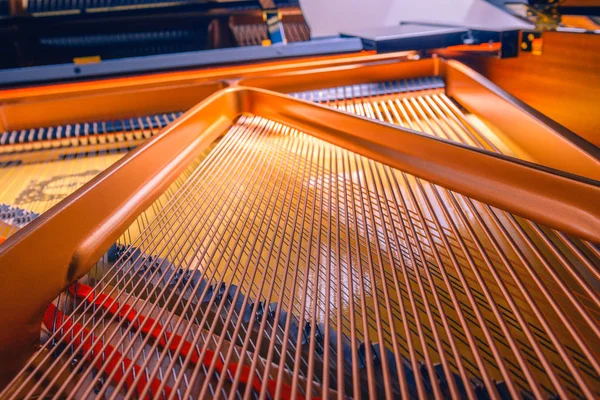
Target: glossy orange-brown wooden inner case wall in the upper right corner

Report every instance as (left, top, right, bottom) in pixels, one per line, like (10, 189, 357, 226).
(450, 32, 600, 147)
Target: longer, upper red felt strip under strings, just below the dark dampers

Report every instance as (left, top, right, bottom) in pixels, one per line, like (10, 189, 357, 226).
(69, 283, 319, 400)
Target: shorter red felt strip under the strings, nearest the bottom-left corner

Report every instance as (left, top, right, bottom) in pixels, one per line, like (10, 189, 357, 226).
(44, 304, 172, 399)
